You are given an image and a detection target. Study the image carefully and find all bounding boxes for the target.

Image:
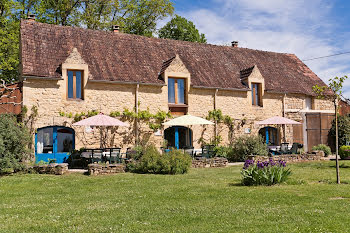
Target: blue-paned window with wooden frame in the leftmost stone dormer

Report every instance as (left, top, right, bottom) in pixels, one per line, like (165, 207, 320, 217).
(67, 70, 84, 99)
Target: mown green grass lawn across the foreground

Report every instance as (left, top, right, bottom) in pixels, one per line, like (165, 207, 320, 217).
(0, 162, 350, 232)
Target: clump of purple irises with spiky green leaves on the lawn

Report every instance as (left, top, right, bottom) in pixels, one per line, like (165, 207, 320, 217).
(241, 159, 291, 186)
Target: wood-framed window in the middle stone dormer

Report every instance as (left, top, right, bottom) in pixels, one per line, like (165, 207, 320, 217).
(168, 78, 186, 104)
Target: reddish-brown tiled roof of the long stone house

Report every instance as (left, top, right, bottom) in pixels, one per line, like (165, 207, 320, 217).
(21, 20, 325, 95)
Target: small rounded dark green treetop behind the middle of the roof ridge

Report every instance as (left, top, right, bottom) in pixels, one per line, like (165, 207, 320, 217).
(159, 15, 207, 43)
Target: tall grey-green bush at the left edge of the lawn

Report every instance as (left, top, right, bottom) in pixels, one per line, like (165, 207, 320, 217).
(0, 114, 30, 174)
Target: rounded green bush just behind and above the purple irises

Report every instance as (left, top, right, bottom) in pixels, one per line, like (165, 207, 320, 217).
(227, 136, 268, 162)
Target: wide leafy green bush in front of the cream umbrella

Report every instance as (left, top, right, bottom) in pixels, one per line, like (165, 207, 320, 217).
(127, 145, 192, 174)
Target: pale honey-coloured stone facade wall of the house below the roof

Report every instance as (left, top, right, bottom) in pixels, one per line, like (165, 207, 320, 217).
(23, 75, 333, 152)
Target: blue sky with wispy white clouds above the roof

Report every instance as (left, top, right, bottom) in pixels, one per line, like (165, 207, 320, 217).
(160, 0, 350, 98)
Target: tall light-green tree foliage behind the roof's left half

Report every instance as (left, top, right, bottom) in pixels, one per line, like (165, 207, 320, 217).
(0, 0, 174, 82)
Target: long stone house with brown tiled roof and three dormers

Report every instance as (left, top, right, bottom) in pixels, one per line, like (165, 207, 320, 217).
(20, 20, 333, 160)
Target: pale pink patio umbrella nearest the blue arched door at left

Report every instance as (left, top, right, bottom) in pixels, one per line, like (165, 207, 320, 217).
(73, 113, 129, 148)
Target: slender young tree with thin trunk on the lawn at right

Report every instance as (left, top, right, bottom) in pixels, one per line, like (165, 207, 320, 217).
(312, 76, 348, 184)
